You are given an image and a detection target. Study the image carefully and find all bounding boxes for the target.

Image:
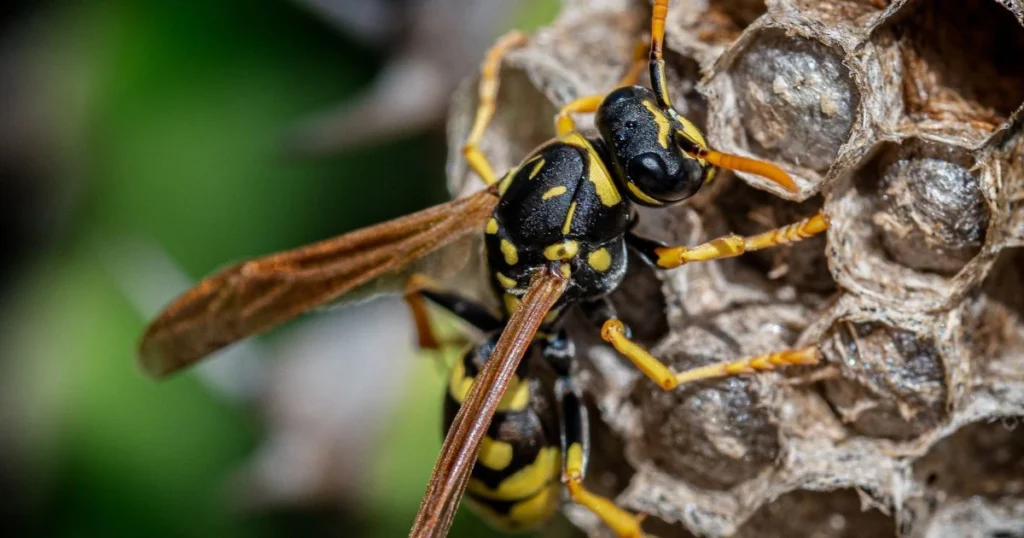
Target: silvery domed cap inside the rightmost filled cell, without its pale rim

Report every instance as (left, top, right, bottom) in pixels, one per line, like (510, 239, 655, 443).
(860, 138, 990, 275)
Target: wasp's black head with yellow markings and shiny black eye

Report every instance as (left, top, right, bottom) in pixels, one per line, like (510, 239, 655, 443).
(595, 86, 708, 206)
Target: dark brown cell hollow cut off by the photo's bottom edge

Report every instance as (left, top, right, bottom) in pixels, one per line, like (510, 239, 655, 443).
(734, 490, 896, 538)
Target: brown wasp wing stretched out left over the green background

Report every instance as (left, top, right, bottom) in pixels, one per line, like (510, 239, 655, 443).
(138, 189, 498, 376)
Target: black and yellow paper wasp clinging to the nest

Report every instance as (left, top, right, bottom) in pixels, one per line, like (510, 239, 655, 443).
(138, 0, 828, 538)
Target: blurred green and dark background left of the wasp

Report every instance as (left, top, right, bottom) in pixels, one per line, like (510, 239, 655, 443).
(0, 0, 557, 537)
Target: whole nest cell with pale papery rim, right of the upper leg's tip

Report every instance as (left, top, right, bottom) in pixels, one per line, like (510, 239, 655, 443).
(825, 136, 992, 312)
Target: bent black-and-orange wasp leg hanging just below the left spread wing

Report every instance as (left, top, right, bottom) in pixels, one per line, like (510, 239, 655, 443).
(403, 273, 502, 349)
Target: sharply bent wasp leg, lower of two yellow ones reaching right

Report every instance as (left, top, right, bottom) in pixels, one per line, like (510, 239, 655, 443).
(585, 299, 821, 390)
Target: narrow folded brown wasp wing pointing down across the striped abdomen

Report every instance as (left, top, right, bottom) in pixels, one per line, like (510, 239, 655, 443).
(409, 270, 568, 538)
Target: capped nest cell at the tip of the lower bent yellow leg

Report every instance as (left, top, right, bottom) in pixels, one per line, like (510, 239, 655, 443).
(821, 319, 947, 441)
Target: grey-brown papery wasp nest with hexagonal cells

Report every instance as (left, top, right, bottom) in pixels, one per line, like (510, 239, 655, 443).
(450, 0, 1024, 538)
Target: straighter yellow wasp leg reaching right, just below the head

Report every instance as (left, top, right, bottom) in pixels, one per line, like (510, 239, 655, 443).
(626, 211, 828, 268)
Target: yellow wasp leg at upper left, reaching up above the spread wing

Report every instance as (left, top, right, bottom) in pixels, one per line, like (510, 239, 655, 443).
(462, 31, 526, 185)
